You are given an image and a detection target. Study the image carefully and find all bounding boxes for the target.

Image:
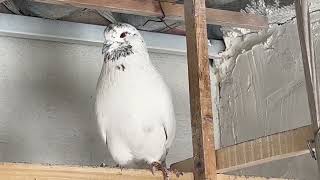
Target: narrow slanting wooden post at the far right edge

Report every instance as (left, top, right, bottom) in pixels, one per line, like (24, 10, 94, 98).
(295, 0, 320, 173)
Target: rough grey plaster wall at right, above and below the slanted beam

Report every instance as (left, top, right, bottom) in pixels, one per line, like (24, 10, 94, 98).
(219, 13, 320, 180)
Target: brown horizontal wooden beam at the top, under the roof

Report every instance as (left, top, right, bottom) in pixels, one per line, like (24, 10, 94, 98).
(36, 0, 268, 30)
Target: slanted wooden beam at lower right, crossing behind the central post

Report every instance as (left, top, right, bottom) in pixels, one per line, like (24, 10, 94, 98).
(172, 126, 313, 173)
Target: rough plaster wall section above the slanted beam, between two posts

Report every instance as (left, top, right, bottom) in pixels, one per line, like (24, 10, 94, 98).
(220, 24, 310, 146)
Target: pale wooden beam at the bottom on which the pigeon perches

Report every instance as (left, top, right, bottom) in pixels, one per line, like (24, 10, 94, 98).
(0, 163, 292, 180)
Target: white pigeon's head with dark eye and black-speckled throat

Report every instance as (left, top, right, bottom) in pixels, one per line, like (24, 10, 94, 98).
(102, 23, 145, 62)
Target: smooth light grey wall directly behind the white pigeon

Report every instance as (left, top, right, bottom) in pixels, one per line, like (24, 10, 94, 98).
(0, 36, 219, 165)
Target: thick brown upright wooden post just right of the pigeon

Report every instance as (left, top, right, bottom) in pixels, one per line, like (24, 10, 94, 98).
(184, 0, 217, 180)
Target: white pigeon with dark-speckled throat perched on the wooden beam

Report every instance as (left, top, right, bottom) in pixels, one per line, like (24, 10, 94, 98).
(96, 24, 176, 175)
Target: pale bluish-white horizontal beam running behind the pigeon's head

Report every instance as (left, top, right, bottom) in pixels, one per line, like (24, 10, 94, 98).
(0, 13, 224, 58)
